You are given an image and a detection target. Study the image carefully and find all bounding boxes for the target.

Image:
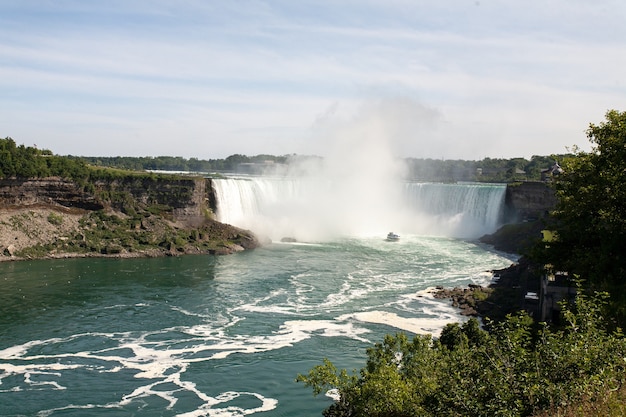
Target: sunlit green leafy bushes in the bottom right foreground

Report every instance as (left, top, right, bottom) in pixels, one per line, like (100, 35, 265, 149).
(297, 293, 626, 417)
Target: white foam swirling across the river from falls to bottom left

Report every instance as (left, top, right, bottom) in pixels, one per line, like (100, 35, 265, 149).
(0, 235, 516, 417)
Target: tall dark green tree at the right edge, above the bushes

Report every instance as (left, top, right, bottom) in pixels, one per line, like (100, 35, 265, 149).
(543, 110, 626, 318)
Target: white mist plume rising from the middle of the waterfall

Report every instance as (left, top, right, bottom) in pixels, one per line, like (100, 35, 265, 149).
(233, 97, 441, 241)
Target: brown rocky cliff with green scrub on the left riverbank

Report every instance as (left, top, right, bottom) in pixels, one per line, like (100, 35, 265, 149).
(0, 174, 258, 260)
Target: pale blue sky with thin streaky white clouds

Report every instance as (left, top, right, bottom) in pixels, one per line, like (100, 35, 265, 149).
(0, 0, 626, 160)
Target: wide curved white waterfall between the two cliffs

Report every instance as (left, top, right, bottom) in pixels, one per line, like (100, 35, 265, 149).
(213, 177, 506, 241)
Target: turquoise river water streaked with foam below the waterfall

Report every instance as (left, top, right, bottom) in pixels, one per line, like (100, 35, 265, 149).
(0, 235, 512, 416)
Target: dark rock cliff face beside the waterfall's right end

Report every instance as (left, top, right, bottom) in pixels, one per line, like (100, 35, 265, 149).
(505, 182, 557, 222)
